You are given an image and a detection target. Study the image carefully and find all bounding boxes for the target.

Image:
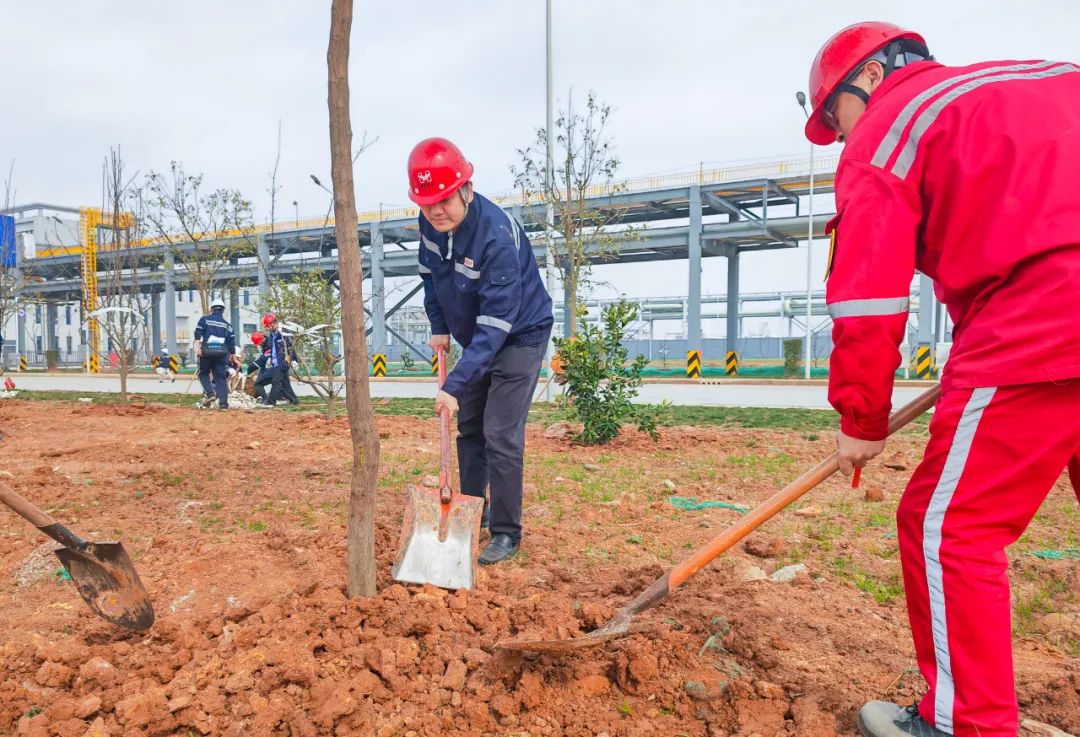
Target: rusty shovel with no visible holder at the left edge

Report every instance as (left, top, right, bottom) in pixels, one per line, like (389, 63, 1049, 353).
(0, 483, 153, 630)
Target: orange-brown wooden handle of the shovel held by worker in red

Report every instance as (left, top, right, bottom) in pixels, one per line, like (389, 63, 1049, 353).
(667, 385, 941, 591)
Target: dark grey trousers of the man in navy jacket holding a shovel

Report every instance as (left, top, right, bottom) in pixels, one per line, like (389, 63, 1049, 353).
(458, 343, 548, 540)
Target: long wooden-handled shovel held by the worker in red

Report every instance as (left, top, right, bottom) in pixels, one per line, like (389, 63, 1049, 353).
(496, 386, 941, 654)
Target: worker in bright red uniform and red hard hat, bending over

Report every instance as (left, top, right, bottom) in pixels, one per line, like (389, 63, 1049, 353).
(806, 23, 1080, 737)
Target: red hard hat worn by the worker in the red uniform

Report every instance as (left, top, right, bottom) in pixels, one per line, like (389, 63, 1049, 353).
(806, 21, 927, 146)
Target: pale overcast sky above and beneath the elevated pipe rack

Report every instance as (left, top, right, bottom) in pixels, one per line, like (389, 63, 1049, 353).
(0, 0, 1080, 332)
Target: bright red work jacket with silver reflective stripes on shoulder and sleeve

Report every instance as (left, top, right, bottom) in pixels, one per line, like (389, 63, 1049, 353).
(826, 62, 1080, 440)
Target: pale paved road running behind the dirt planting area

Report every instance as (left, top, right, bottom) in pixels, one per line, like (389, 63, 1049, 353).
(8, 374, 922, 410)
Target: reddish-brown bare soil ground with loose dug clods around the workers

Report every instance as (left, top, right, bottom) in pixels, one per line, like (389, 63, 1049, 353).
(0, 401, 1080, 737)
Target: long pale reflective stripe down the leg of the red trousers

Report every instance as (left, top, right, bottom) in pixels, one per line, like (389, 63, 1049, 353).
(922, 387, 997, 733)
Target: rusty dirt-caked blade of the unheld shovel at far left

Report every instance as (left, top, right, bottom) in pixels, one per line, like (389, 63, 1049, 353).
(53, 542, 153, 631)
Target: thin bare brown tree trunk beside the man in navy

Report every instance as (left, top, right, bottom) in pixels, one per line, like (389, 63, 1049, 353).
(326, 0, 379, 597)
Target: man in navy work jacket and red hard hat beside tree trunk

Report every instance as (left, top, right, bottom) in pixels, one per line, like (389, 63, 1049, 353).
(408, 138, 554, 564)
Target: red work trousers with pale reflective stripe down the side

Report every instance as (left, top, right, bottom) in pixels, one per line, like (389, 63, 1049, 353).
(896, 379, 1080, 737)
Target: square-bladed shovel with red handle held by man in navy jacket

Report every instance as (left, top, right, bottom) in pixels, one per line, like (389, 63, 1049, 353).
(391, 347, 484, 589)
